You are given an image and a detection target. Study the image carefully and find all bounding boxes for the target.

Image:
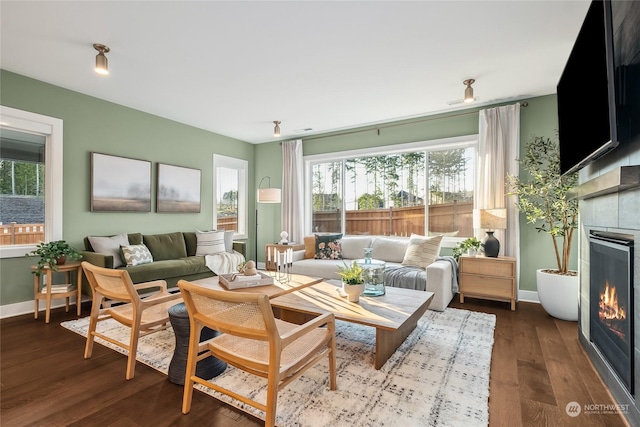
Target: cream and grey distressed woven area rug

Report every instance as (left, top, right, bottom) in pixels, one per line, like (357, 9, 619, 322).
(62, 308, 495, 427)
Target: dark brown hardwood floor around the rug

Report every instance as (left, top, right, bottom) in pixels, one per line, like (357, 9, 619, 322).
(0, 298, 628, 427)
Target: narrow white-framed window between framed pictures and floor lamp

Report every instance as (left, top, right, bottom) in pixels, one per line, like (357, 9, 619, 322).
(213, 154, 249, 239)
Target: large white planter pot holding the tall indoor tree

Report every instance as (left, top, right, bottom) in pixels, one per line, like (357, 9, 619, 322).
(536, 269, 580, 321)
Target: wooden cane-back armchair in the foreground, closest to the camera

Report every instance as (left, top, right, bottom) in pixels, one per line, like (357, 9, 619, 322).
(178, 280, 336, 427)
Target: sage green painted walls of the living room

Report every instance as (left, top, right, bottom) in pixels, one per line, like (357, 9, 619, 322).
(0, 70, 577, 305)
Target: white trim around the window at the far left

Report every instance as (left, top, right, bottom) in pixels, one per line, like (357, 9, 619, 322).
(0, 105, 63, 258)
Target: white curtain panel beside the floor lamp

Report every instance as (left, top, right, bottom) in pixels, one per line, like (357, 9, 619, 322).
(281, 139, 304, 243)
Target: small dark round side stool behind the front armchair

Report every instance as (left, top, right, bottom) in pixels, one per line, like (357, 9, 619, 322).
(169, 302, 227, 385)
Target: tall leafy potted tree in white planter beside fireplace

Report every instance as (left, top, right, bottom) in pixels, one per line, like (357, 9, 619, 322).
(507, 136, 580, 321)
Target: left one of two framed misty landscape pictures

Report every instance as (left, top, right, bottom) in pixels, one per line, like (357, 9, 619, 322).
(91, 153, 151, 212)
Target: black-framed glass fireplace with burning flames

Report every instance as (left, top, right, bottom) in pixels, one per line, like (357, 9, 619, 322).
(589, 231, 634, 395)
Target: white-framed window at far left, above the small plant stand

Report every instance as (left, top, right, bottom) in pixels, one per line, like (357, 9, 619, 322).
(0, 106, 63, 258)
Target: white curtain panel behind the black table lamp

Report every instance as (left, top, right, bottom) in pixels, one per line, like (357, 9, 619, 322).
(473, 103, 520, 259)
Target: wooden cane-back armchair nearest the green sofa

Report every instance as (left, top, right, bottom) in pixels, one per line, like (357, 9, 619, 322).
(82, 261, 182, 380)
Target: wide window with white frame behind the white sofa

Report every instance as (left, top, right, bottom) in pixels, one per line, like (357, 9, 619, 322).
(305, 136, 477, 246)
